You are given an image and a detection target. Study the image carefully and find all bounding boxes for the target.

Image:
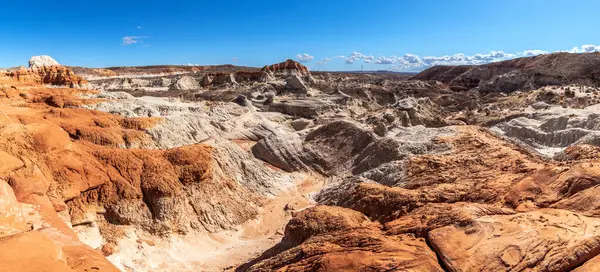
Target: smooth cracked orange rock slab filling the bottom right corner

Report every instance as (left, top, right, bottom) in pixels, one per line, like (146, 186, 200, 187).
(429, 209, 600, 271)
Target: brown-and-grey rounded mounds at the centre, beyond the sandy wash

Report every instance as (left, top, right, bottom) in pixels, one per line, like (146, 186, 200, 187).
(253, 121, 452, 176)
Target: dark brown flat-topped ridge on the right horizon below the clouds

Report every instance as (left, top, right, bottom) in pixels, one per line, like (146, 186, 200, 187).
(412, 53, 600, 93)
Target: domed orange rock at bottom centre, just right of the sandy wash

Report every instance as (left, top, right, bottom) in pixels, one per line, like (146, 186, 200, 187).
(247, 206, 443, 272)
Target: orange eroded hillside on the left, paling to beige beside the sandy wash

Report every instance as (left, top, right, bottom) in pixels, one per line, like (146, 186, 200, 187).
(0, 67, 294, 271)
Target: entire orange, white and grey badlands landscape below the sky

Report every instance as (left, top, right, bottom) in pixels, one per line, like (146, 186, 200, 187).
(0, 53, 600, 272)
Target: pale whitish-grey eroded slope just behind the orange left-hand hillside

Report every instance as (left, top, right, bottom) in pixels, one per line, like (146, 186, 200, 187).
(86, 92, 288, 148)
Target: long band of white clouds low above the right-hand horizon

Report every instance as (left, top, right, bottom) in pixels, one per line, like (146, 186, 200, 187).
(296, 44, 600, 71)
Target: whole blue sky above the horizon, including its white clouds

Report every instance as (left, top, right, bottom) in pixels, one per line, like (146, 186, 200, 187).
(0, 0, 600, 70)
